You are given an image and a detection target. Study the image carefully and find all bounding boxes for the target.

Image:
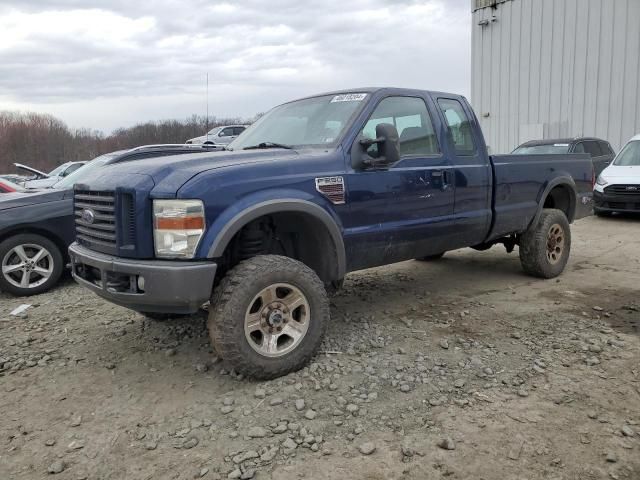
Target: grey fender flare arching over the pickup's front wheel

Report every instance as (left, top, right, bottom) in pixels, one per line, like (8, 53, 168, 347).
(207, 198, 347, 280)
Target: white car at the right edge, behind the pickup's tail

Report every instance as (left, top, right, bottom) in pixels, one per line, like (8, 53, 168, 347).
(593, 135, 640, 216)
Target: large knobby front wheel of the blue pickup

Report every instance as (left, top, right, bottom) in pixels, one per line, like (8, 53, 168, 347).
(209, 255, 330, 379)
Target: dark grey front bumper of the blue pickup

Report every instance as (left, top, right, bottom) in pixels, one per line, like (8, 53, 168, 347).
(69, 243, 217, 313)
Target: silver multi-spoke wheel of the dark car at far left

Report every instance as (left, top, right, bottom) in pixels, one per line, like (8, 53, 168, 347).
(0, 233, 64, 296)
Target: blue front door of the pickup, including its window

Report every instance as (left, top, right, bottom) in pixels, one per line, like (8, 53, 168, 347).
(346, 96, 454, 269)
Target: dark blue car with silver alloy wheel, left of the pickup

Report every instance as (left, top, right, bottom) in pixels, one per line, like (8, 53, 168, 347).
(0, 145, 220, 295)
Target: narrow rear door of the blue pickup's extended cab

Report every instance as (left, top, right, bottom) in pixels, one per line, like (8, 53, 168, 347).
(437, 97, 492, 248)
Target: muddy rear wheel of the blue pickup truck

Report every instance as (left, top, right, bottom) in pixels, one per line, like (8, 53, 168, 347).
(520, 209, 571, 278)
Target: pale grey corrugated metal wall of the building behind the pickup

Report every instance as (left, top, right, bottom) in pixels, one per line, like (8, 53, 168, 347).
(471, 0, 640, 153)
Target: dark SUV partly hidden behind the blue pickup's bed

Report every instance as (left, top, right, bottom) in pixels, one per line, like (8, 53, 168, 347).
(513, 137, 616, 176)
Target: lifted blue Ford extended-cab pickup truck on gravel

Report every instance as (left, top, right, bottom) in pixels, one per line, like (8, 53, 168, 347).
(70, 88, 594, 379)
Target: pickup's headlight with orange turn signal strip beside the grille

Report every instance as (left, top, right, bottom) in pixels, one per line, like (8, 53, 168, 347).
(153, 200, 205, 258)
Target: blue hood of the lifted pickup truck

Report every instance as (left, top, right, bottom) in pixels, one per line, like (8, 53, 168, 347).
(80, 149, 298, 198)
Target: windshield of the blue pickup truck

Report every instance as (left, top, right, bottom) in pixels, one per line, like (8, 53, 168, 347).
(227, 93, 367, 150)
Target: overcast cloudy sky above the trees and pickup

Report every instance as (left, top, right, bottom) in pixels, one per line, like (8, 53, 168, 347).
(0, 0, 471, 132)
